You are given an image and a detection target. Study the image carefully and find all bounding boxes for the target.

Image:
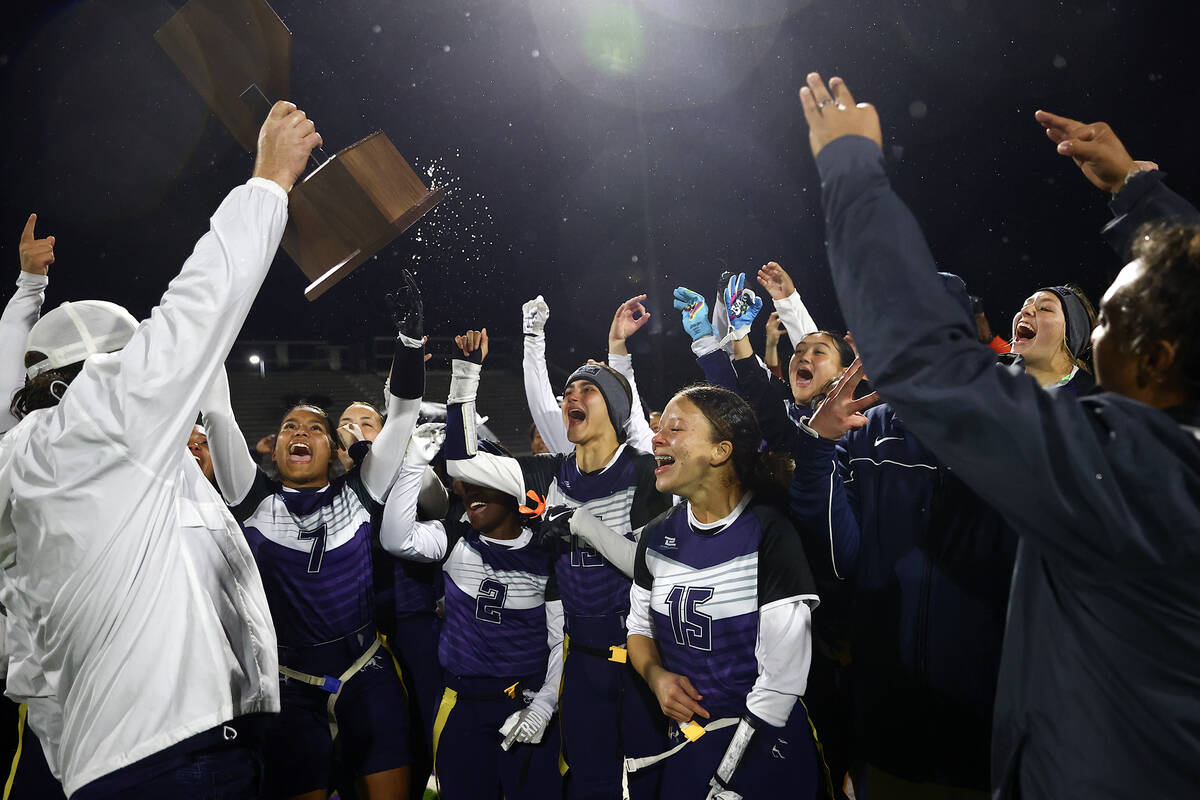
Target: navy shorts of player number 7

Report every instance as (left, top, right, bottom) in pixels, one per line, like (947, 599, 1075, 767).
(263, 642, 410, 796)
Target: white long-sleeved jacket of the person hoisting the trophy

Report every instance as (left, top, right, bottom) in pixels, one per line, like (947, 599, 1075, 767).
(0, 179, 287, 795)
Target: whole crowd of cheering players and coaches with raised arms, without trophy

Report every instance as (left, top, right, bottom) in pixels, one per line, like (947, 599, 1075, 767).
(0, 67, 1200, 800)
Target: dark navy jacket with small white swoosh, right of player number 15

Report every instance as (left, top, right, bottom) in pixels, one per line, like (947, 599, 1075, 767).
(791, 405, 1016, 788)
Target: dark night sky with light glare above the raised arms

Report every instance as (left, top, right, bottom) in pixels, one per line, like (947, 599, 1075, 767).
(0, 0, 1200, 407)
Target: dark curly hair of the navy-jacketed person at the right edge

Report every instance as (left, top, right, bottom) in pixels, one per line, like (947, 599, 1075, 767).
(1121, 223, 1200, 399)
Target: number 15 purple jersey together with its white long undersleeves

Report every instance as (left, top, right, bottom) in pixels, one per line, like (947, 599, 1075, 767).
(630, 495, 817, 726)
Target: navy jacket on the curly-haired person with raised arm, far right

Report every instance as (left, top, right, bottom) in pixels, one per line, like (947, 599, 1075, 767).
(817, 137, 1200, 799)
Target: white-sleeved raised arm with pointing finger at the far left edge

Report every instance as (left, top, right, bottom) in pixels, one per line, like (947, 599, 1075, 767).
(0, 213, 54, 433)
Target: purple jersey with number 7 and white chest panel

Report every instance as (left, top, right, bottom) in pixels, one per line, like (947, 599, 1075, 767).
(232, 469, 380, 648)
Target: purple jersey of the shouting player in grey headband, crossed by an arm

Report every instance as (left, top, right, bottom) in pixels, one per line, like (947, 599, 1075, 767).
(520, 445, 671, 628)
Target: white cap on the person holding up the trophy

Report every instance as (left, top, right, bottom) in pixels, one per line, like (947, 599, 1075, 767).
(25, 300, 138, 378)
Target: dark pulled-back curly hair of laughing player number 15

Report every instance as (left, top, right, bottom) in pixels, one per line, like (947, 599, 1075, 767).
(676, 384, 791, 503)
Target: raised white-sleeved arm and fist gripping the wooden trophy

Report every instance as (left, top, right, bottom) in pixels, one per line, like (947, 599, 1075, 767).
(70, 101, 320, 474)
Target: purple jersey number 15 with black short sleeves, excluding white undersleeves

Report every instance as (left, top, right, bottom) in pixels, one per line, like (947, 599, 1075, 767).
(635, 501, 816, 718)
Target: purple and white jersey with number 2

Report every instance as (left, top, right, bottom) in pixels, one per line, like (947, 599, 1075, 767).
(438, 523, 558, 678)
